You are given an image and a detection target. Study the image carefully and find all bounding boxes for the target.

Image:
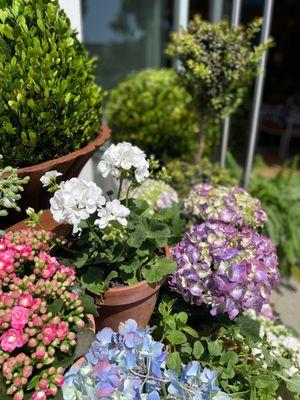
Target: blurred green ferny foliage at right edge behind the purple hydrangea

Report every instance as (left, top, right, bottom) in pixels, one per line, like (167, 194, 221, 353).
(249, 158, 300, 274)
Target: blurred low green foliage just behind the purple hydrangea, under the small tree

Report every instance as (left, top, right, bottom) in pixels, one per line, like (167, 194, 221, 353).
(166, 159, 238, 196)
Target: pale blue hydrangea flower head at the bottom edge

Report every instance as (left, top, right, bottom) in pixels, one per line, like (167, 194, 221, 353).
(63, 320, 229, 400)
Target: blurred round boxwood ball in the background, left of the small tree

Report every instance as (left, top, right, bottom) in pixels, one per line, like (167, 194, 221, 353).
(106, 69, 197, 159)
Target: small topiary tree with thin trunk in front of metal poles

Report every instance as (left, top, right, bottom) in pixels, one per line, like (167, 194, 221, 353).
(167, 16, 271, 159)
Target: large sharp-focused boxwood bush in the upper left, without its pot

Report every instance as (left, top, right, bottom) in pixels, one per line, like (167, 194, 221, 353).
(0, 0, 103, 167)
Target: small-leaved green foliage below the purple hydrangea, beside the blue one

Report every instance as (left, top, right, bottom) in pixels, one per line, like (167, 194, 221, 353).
(153, 297, 300, 400)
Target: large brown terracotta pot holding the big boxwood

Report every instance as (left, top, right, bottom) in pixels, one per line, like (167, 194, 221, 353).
(1, 125, 110, 229)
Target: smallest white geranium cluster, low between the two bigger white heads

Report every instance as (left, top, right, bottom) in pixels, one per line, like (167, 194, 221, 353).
(95, 199, 130, 229)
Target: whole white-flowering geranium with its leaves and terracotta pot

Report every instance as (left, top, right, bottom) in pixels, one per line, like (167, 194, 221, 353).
(36, 142, 183, 329)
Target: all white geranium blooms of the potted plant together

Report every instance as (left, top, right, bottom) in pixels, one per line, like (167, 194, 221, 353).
(46, 142, 149, 233)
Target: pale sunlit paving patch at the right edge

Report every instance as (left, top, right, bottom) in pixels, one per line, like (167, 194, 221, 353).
(271, 279, 300, 332)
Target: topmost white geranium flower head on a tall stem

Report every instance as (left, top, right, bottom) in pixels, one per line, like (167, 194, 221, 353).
(97, 142, 149, 182)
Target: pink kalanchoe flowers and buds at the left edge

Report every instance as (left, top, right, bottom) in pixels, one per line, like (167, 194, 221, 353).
(0, 229, 84, 400)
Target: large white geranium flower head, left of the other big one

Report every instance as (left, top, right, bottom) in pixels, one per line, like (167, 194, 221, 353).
(50, 178, 105, 233)
